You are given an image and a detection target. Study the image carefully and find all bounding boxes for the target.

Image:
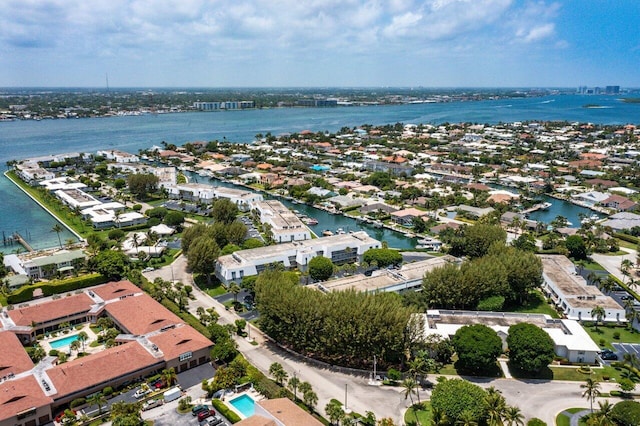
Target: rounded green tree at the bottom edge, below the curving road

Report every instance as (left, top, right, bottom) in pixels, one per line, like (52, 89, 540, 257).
(431, 379, 487, 424)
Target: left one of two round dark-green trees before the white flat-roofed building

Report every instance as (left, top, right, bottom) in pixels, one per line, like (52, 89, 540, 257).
(451, 324, 502, 373)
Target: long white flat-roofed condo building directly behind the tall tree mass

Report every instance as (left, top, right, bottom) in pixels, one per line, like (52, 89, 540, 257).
(216, 231, 382, 284)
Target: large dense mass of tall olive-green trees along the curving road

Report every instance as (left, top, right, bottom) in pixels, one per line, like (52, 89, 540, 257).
(255, 270, 413, 368)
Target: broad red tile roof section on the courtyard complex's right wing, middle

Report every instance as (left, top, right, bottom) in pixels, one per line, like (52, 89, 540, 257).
(105, 294, 182, 335)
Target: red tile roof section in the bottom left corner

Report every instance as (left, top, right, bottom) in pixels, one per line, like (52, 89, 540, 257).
(0, 376, 53, 420)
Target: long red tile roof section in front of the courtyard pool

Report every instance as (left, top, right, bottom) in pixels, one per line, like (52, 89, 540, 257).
(47, 342, 159, 397)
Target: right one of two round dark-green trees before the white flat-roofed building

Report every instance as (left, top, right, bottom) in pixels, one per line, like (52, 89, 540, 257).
(507, 323, 555, 373)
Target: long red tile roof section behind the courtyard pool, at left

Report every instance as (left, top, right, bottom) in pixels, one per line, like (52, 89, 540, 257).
(9, 293, 93, 326)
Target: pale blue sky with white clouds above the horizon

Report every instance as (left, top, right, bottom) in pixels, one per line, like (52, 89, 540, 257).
(0, 0, 640, 88)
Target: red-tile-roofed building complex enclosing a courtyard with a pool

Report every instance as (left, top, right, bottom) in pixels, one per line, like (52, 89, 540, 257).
(0, 281, 213, 426)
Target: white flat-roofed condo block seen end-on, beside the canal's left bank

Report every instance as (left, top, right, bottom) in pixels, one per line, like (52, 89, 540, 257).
(253, 200, 311, 243)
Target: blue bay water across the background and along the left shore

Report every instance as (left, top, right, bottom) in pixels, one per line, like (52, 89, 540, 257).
(0, 95, 640, 252)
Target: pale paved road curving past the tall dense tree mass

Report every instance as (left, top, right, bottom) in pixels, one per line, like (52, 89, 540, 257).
(145, 256, 628, 424)
